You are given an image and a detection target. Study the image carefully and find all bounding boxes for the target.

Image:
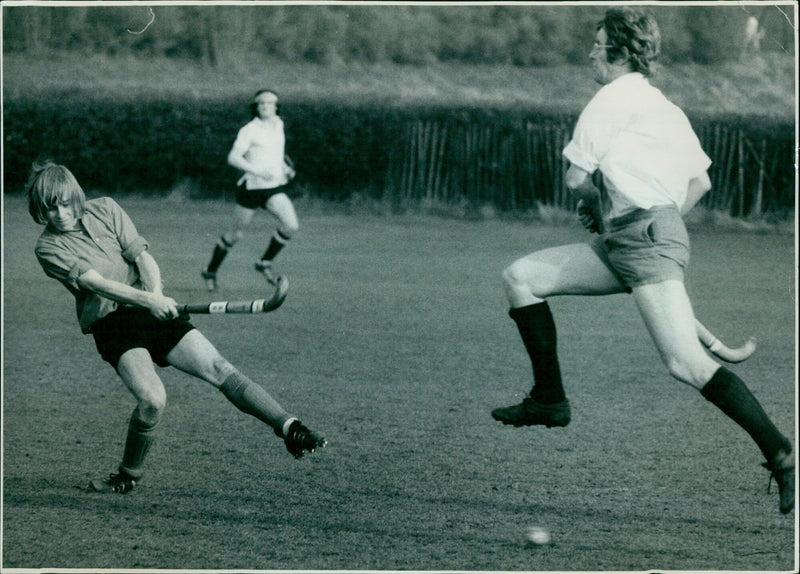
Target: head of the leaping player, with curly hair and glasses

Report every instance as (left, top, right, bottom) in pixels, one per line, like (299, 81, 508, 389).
(597, 6, 661, 77)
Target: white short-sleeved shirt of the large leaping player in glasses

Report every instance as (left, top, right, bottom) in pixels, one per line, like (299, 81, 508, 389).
(563, 72, 711, 218)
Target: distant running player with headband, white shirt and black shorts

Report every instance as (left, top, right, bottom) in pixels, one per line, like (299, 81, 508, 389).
(202, 89, 300, 291)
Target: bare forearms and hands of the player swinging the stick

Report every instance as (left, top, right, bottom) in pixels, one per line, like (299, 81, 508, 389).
(78, 251, 178, 320)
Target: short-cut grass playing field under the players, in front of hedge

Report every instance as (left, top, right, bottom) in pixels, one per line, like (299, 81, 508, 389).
(2, 196, 798, 572)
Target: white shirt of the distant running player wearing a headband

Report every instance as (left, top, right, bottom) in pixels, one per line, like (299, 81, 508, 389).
(233, 116, 288, 189)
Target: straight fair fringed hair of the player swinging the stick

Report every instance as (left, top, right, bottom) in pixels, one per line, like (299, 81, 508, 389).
(25, 159, 86, 224)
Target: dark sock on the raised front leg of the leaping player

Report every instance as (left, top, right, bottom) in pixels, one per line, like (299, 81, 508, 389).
(508, 301, 567, 404)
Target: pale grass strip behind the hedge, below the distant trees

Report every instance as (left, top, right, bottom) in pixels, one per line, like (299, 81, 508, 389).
(3, 54, 795, 119)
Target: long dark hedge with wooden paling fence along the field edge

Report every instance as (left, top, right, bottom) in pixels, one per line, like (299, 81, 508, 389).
(3, 93, 795, 216)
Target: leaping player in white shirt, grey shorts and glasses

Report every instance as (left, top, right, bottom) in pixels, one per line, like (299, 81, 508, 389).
(492, 7, 795, 513)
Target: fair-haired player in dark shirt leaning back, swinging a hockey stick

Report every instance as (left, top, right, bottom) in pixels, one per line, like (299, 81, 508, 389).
(26, 161, 326, 493)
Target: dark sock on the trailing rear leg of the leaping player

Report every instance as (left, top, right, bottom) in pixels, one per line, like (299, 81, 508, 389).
(700, 367, 792, 461)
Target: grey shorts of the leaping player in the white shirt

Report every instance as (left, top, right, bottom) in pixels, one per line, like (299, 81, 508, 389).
(590, 206, 689, 291)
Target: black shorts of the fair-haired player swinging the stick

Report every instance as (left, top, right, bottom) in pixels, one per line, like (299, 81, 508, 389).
(92, 307, 194, 369)
